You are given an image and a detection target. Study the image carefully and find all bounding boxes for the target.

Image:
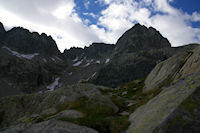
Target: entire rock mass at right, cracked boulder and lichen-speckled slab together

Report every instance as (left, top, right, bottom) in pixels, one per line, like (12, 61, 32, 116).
(128, 47, 200, 133)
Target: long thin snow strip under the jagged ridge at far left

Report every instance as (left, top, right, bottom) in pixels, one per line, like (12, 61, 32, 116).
(2, 46, 39, 60)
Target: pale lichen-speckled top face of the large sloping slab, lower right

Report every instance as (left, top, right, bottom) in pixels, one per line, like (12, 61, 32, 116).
(128, 72, 200, 133)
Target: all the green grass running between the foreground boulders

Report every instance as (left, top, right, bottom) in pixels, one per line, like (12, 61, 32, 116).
(56, 80, 160, 133)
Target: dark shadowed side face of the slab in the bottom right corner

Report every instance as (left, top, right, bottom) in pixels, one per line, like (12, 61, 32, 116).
(154, 88, 200, 133)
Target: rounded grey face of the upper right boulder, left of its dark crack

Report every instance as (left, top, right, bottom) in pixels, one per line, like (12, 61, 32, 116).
(144, 52, 191, 92)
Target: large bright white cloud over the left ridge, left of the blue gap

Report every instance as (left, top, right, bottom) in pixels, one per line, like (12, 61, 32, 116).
(0, 0, 100, 51)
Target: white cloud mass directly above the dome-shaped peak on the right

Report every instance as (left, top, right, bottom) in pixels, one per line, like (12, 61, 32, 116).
(94, 0, 200, 46)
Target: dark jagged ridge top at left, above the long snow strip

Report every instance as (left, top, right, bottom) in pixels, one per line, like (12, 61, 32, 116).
(2, 23, 60, 55)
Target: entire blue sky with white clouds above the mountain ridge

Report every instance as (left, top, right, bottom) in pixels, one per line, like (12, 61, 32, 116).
(0, 0, 200, 51)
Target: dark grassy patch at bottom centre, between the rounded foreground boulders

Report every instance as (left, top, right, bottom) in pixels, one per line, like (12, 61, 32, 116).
(57, 97, 129, 133)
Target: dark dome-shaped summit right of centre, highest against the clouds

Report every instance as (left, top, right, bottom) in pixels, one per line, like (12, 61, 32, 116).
(115, 24, 171, 52)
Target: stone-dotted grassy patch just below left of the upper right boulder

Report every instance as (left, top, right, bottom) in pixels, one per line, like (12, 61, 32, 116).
(101, 79, 161, 113)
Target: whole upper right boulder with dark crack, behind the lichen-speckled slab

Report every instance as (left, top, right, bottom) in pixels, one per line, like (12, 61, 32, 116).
(144, 47, 200, 92)
